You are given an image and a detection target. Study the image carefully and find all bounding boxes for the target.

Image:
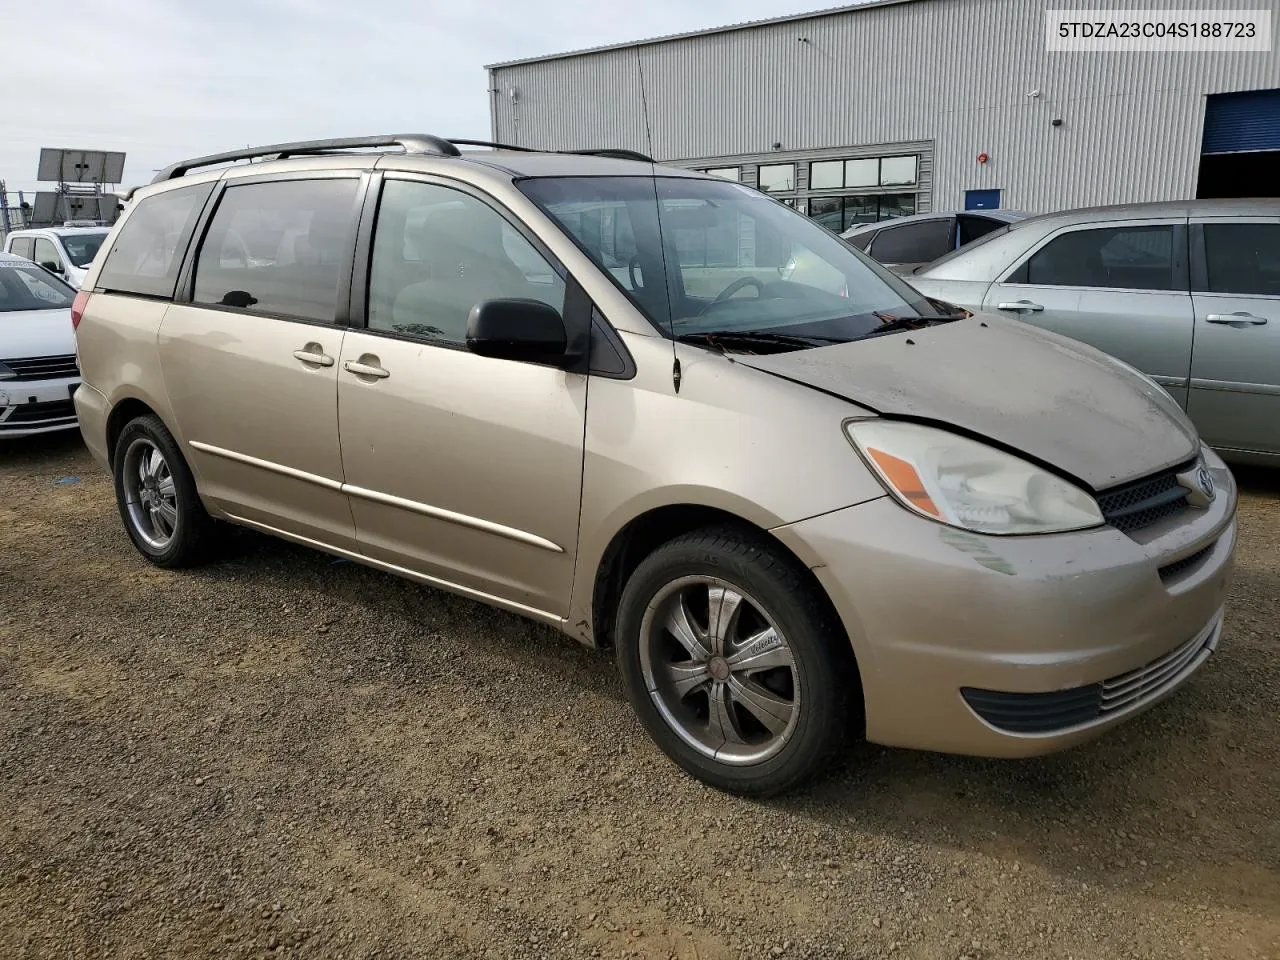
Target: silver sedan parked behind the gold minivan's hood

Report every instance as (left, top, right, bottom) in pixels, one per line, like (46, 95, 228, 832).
(909, 200, 1280, 465)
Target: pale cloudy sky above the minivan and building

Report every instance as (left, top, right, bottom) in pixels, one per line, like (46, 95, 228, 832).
(0, 0, 838, 193)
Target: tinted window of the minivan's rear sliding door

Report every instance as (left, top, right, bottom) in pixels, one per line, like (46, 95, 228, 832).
(193, 178, 358, 323)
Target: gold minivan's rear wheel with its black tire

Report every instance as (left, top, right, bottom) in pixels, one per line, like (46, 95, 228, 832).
(111, 413, 214, 568)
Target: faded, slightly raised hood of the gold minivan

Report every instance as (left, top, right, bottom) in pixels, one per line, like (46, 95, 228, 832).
(733, 315, 1199, 490)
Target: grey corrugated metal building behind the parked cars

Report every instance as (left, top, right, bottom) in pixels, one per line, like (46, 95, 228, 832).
(488, 0, 1280, 220)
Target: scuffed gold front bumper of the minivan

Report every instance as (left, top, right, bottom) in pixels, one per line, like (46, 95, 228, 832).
(773, 452, 1236, 756)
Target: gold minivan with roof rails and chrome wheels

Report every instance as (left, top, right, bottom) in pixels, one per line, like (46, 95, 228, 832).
(73, 136, 1236, 795)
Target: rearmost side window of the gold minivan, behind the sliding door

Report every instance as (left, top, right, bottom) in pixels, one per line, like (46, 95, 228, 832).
(97, 183, 214, 297)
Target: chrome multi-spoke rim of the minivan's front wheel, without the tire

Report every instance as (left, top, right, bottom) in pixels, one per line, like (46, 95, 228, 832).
(640, 576, 801, 765)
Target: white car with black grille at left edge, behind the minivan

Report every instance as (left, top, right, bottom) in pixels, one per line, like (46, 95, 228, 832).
(0, 253, 81, 439)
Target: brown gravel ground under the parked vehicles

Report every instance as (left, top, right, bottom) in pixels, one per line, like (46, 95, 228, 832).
(0, 435, 1280, 960)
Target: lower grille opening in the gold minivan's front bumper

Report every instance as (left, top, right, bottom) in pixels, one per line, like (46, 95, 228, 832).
(960, 617, 1219, 733)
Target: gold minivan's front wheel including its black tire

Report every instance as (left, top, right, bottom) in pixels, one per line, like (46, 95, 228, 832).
(617, 527, 860, 796)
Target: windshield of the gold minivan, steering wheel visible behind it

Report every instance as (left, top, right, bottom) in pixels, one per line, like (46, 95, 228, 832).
(520, 177, 937, 342)
